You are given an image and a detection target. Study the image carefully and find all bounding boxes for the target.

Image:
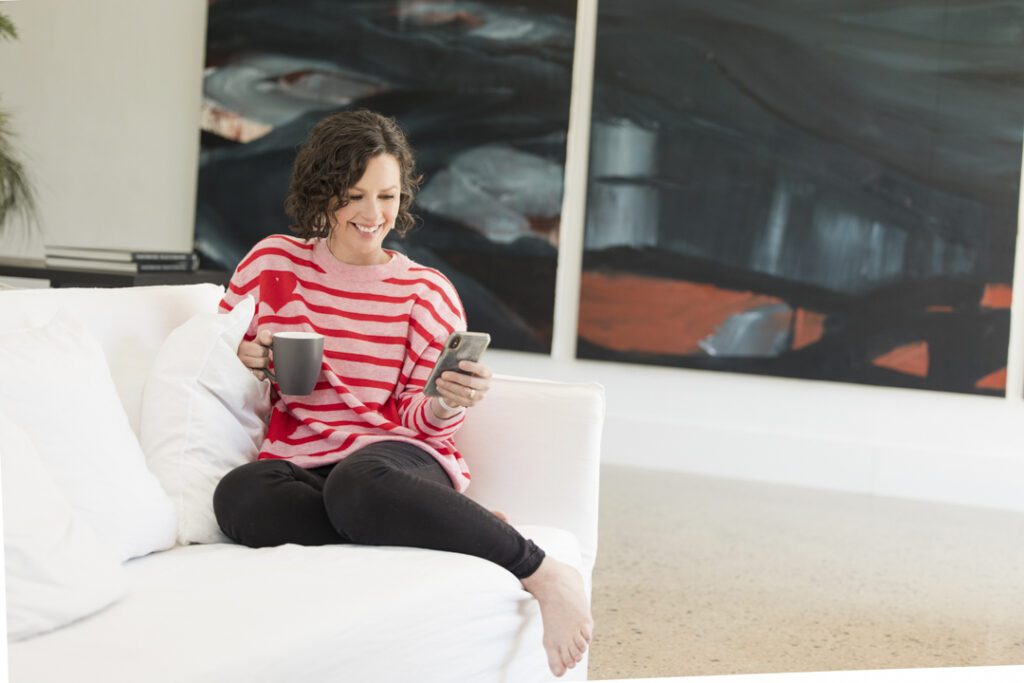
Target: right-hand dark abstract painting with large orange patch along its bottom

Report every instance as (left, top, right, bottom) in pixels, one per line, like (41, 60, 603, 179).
(579, 0, 1024, 395)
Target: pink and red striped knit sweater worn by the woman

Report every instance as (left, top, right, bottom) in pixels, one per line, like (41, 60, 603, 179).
(220, 234, 470, 492)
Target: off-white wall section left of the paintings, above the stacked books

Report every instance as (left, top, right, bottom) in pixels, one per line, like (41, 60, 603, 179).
(0, 0, 207, 255)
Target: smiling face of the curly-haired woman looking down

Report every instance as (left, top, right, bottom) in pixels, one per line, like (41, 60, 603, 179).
(328, 154, 401, 265)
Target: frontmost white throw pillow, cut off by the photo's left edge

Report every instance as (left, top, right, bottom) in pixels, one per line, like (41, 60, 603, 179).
(0, 413, 125, 641)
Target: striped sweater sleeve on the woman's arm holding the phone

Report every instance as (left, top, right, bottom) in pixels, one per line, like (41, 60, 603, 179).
(397, 281, 466, 438)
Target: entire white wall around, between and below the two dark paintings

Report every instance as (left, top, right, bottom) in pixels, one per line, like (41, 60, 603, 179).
(0, 0, 1024, 510)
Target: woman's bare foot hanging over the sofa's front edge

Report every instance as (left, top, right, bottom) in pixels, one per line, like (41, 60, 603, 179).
(522, 557, 594, 676)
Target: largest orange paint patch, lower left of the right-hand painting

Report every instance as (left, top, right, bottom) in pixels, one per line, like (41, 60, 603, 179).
(580, 272, 782, 355)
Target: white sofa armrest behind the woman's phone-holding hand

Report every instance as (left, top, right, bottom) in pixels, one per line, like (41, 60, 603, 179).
(456, 375, 604, 575)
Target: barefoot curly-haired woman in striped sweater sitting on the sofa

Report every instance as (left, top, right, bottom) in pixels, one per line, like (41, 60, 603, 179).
(214, 111, 593, 676)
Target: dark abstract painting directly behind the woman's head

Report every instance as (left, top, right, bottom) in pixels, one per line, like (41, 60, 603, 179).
(196, 0, 575, 351)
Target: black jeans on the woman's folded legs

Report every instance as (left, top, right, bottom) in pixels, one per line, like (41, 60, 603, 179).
(213, 441, 545, 579)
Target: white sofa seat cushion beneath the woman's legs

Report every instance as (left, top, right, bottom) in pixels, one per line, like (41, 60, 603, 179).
(9, 525, 582, 683)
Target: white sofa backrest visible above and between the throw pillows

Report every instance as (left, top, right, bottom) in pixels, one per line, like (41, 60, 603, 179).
(0, 284, 223, 434)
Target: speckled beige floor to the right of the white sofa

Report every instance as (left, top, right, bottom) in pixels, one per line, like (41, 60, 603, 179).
(590, 466, 1024, 679)
